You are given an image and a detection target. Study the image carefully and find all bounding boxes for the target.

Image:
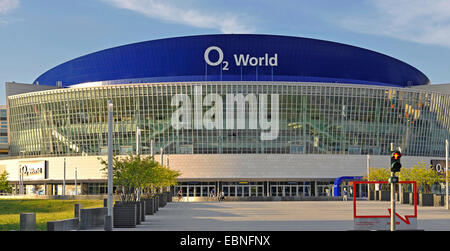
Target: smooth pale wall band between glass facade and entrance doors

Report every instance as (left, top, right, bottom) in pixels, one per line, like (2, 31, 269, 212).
(0, 154, 443, 183)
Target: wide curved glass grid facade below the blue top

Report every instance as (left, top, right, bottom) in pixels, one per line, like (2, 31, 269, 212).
(8, 82, 450, 156)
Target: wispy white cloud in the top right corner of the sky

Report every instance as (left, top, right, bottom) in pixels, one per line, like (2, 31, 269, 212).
(339, 0, 450, 47)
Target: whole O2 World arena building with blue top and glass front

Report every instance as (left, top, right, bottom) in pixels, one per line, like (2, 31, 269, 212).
(0, 34, 450, 197)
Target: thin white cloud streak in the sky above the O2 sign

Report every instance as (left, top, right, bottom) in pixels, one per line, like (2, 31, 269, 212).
(103, 0, 253, 33)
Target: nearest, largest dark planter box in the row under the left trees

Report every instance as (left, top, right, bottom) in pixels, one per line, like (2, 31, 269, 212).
(113, 202, 137, 228)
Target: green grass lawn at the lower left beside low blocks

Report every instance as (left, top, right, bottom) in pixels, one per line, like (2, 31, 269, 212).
(0, 199, 103, 231)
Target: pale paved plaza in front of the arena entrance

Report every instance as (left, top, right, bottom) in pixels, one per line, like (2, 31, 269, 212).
(109, 201, 450, 231)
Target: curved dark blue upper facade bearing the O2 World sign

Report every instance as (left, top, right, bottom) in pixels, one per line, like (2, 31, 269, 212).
(34, 34, 429, 87)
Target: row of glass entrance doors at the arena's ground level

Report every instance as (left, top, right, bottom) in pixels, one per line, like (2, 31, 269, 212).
(174, 185, 318, 197)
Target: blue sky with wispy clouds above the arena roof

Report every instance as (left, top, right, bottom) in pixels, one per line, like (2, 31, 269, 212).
(0, 0, 450, 104)
